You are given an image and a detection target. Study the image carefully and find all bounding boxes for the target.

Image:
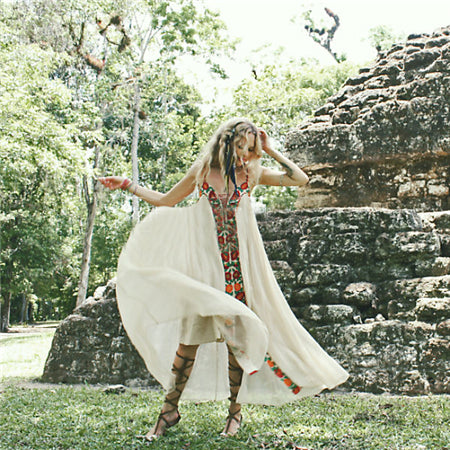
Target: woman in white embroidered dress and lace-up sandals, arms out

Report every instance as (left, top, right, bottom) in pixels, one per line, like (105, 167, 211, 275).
(100, 119, 348, 440)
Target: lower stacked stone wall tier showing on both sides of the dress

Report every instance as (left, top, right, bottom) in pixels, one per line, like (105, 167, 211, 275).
(44, 208, 450, 394)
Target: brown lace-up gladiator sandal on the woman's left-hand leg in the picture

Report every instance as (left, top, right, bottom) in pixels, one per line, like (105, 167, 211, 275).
(145, 352, 195, 441)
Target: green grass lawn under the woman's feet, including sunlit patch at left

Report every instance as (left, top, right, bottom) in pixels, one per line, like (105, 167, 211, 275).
(0, 326, 450, 450)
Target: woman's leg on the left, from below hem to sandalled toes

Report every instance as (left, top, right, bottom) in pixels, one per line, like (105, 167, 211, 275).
(145, 344, 198, 440)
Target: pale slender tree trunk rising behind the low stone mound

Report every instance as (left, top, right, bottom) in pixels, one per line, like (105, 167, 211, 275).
(76, 148, 100, 307)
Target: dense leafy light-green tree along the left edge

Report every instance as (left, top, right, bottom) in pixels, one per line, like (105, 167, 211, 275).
(0, 45, 83, 312)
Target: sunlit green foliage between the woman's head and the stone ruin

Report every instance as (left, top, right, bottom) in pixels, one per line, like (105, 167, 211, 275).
(224, 60, 358, 209)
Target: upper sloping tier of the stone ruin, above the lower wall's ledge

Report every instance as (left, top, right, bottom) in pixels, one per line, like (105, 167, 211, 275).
(286, 28, 450, 211)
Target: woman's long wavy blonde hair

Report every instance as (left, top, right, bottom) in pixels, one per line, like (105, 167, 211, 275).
(196, 118, 263, 187)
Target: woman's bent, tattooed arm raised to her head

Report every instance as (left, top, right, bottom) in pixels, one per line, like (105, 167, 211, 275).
(259, 129, 309, 186)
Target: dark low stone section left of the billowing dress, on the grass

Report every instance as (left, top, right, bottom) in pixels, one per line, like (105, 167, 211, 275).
(42, 296, 156, 386)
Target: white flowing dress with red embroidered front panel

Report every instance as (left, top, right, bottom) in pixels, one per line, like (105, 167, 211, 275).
(117, 181, 348, 405)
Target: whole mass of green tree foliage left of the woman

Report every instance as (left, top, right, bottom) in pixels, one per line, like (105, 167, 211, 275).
(0, 0, 232, 318)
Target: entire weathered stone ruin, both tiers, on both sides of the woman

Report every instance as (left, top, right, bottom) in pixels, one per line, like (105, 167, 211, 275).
(43, 28, 450, 395)
